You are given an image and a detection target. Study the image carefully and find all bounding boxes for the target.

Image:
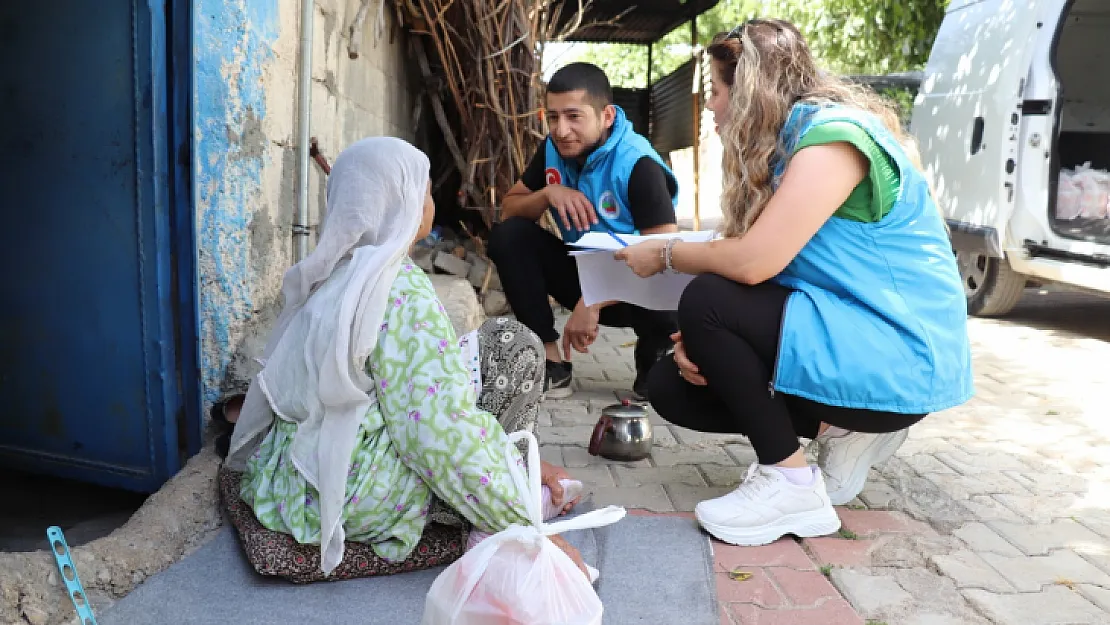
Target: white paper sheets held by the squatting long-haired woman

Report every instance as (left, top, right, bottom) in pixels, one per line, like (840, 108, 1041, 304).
(571, 231, 714, 311)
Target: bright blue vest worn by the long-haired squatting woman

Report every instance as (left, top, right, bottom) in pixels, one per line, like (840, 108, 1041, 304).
(771, 102, 973, 414)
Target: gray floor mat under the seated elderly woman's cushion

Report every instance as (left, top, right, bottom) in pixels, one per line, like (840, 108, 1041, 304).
(98, 516, 719, 625)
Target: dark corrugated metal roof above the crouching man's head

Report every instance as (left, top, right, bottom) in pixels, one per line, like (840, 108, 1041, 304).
(559, 0, 719, 43)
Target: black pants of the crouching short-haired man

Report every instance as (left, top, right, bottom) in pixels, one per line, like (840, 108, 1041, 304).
(488, 216, 678, 371)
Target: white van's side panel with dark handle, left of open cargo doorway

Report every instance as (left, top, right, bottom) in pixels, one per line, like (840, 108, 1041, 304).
(912, 0, 1062, 258)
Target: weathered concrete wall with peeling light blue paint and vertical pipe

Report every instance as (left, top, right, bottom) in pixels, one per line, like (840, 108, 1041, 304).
(193, 0, 413, 404)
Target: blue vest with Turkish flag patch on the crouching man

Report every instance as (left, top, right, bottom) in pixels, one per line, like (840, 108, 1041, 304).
(544, 105, 678, 243)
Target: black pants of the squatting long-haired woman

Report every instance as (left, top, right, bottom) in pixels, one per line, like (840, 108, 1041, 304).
(648, 274, 925, 464)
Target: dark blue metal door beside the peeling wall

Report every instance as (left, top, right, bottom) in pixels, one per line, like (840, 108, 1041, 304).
(0, 0, 195, 491)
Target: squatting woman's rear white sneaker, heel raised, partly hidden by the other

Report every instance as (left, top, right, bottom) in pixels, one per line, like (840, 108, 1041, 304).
(815, 430, 909, 505)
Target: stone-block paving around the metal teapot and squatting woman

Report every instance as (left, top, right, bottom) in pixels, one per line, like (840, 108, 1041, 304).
(541, 291, 1110, 625)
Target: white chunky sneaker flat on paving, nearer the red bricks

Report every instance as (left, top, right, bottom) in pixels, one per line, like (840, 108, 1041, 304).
(694, 463, 840, 546)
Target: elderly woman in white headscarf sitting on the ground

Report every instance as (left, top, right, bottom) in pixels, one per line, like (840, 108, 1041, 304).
(216, 138, 582, 574)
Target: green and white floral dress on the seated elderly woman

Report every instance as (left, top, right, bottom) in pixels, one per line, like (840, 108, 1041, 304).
(241, 259, 526, 561)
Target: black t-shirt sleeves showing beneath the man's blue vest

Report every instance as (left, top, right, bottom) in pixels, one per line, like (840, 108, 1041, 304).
(521, 140, 676, 231)
